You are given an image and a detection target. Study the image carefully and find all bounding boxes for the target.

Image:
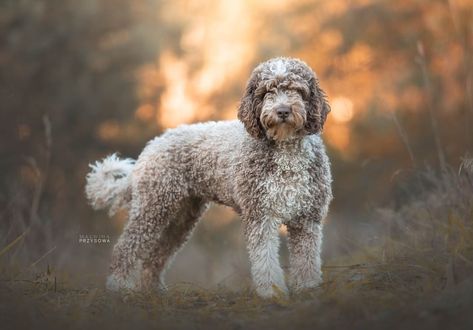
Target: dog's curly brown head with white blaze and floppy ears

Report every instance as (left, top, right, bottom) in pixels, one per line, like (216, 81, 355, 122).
(238, 58, 330, 141)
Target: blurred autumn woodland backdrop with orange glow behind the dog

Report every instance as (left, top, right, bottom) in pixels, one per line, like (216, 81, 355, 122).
(0, 0, 473, 287)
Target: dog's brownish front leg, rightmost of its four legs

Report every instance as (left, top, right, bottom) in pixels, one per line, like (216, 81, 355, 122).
(288, 220, 322, 291)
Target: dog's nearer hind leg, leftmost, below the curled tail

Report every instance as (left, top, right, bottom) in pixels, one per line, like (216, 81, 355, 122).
(107, 168, 192, 291)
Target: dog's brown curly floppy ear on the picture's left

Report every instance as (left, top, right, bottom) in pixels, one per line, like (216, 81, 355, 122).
(238, 70, 266, 139)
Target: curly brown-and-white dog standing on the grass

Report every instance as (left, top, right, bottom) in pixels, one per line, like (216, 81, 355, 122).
(86, 58, 332, 297)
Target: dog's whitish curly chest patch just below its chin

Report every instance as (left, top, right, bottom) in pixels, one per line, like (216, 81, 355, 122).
(264, 143, 313, 222)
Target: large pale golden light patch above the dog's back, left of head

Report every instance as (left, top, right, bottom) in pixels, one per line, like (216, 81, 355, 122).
(135, 0, 264, 128)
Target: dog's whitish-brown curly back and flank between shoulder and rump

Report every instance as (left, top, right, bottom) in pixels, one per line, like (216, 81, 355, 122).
(132, 120, 247, 207)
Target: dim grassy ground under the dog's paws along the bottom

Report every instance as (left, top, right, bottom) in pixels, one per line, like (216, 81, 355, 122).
(0, 249, 473, 330)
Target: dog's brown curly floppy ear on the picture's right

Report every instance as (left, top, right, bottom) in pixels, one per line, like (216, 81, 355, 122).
(305, 75, 330, 134)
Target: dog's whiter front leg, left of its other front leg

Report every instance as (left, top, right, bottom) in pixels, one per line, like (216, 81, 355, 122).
(244, 217, 287, 298)
